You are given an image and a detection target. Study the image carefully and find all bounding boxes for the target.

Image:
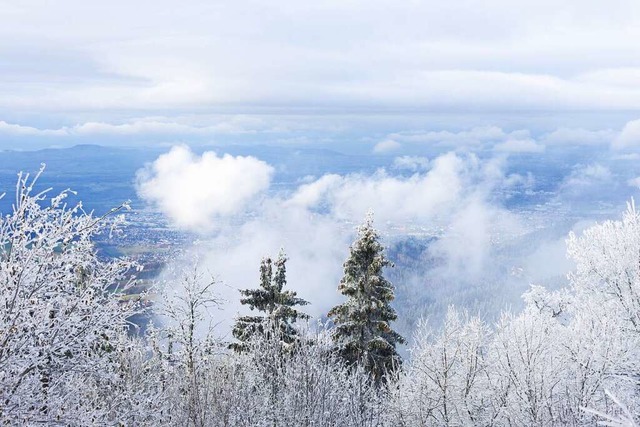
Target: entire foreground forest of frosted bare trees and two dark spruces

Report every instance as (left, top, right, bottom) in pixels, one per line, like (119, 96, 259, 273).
(0, 169, 640, 427)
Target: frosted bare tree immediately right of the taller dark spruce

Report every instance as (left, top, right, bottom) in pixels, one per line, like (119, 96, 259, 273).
(390, 307, 492, 426)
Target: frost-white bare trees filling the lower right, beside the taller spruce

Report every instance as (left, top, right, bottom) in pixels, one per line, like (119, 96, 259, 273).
(389, 202, 640, 427)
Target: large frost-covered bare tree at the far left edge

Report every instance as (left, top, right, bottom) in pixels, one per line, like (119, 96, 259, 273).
(0, 167, 145, 425)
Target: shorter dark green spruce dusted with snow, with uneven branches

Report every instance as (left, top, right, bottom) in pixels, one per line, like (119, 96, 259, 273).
(230, 249, 309, 351)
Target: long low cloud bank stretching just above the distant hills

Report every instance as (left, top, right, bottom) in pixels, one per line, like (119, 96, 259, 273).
(0, 114, 640, 157)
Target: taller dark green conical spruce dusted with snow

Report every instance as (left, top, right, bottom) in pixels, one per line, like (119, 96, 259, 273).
(329, 214, 406, 382)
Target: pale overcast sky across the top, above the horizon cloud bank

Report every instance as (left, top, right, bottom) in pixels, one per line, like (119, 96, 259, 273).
(0, 0, 640, 147)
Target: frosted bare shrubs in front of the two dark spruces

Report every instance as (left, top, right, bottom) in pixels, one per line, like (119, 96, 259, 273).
(233, 322, 385, 427)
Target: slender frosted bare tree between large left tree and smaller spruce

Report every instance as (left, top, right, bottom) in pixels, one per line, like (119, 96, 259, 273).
(148, 263, 222, 427)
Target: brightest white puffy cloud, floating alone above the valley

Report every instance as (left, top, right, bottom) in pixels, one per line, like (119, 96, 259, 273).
(137, 146, 274, 232)
